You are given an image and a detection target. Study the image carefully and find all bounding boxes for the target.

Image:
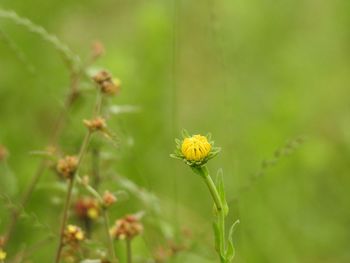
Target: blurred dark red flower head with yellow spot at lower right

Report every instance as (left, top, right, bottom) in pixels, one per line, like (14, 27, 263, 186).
(74, 197, 100, 220)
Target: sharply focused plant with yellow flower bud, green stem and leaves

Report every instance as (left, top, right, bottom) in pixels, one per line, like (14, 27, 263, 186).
(170, 130, 239, 263)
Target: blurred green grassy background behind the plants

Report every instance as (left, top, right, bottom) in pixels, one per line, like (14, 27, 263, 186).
(0, 0, 350, 263)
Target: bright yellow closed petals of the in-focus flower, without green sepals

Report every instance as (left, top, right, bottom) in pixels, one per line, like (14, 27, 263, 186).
(181, 134, 211, 161)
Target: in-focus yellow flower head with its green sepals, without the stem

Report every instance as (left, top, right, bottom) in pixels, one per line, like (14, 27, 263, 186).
(170, 130, 220, 167)
